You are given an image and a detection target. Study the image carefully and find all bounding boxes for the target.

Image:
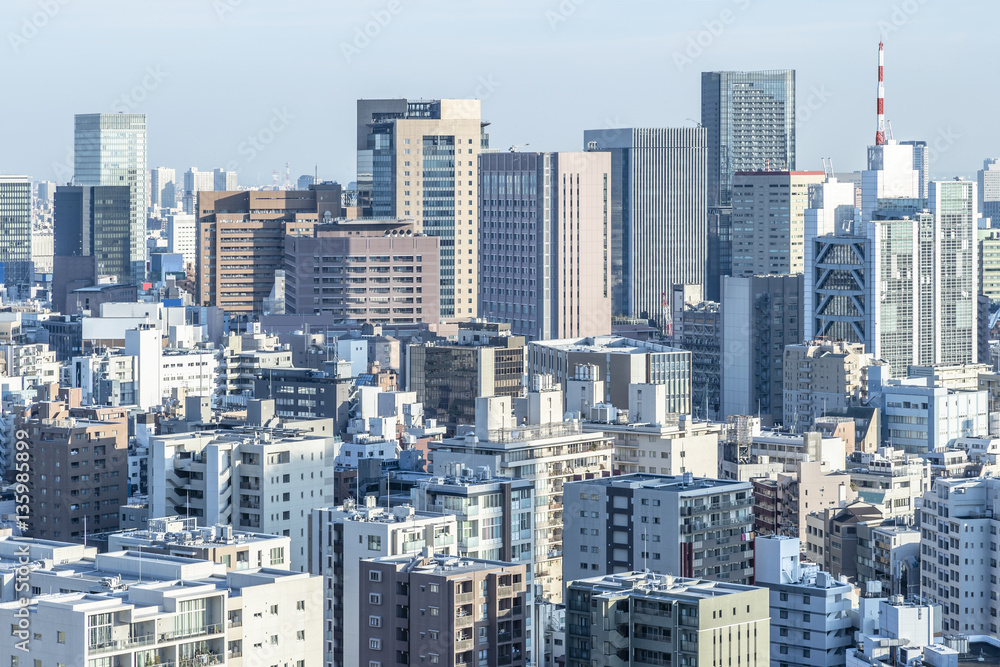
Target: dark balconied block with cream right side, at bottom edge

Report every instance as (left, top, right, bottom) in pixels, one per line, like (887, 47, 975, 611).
(566, 571, 771, 667)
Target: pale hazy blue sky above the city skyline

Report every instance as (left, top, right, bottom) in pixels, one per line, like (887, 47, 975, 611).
(0, 0, 1000, 185)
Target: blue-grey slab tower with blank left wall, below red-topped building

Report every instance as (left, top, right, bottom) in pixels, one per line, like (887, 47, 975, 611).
(721, 275, 803, 425)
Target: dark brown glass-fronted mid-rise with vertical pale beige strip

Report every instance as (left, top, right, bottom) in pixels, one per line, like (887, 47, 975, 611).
(406, 322, 524, 433)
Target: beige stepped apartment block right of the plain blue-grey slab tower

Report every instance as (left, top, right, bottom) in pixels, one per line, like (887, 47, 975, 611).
(782, 340, 872, 433)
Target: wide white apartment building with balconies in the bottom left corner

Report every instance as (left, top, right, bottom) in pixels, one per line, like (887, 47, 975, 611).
(0, 551, 323, 667)
